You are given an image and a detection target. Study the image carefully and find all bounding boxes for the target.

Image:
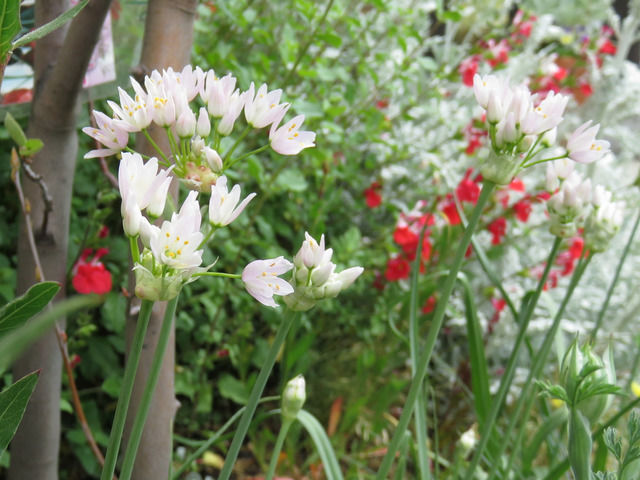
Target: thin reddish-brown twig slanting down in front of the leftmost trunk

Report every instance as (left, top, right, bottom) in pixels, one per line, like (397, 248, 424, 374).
(11, 148, 117, 480)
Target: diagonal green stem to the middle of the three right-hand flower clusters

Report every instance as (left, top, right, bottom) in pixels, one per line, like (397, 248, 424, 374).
(465, 237, 562, 478)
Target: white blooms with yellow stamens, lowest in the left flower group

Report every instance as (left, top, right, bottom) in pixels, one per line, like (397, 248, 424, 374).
(149, 191, 204, 271)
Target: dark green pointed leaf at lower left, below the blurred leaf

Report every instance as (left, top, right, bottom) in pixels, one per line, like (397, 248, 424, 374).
(0, 372, 39, 456)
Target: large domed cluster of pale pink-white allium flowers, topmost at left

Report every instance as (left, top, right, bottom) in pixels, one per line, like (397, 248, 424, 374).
(83, 65, 315, 193)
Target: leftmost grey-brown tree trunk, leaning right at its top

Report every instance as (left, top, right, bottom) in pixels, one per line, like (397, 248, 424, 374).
(9, 0, 110, 480)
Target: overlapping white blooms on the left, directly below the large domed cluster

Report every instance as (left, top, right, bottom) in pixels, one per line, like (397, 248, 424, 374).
(118, 152, 173, 232)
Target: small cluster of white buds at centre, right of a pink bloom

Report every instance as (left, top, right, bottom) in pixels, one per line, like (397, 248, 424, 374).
(284, 232, 364, 311)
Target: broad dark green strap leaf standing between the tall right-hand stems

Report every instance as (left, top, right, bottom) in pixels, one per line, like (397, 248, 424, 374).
(458, 272, 491, 425)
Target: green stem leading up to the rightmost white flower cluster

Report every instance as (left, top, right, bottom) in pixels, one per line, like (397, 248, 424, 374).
(489, 256, 592, 480)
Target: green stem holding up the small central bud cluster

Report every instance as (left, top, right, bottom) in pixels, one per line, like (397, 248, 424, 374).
(220, 310, 299, 480)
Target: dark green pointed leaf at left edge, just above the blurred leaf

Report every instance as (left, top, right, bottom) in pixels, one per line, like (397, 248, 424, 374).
(0, 282, 60, 336)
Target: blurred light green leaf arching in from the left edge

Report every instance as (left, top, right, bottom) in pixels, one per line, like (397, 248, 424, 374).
(0, 295, 104, 373)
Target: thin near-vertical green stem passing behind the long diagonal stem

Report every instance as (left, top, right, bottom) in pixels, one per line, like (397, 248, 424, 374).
(409, 224, 430, 480)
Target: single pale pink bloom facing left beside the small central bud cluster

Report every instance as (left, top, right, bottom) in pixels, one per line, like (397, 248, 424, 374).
(242, 257, 293, 307)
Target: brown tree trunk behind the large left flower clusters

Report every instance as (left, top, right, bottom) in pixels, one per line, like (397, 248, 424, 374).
(125, 0, 197, 480)
